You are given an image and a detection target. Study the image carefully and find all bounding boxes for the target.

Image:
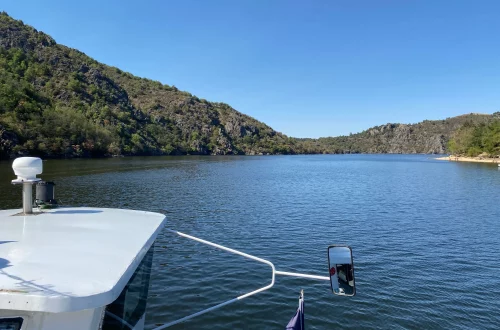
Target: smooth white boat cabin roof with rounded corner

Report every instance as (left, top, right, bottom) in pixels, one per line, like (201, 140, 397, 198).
(0, 208, 165, 313)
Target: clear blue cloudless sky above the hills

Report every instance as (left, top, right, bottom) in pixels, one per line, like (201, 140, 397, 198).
(0, 0, 500, 137)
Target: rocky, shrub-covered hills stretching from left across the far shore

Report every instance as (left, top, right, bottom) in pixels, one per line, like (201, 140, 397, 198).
(0, 12, 493, 159)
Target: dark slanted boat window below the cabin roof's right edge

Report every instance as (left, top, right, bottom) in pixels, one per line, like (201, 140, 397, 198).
(102, 245, 154, 330)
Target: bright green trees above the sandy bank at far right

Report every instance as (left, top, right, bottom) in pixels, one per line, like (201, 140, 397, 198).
(449, 112, 500, 157)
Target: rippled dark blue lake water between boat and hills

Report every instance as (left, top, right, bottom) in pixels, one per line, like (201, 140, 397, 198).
(0, 155, 500, 329)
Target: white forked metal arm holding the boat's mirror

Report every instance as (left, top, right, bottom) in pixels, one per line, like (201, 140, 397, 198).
(153, 228, 330, 330)
